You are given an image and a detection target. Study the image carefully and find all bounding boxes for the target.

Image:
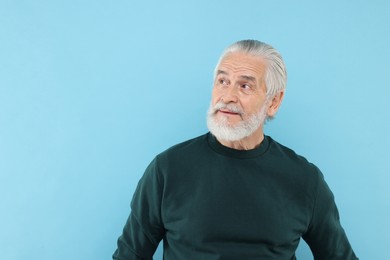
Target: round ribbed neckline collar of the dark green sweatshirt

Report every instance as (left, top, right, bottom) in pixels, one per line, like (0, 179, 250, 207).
(207, 133, 270, 159)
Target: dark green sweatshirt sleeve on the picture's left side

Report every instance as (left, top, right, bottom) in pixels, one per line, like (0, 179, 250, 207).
(113, 159, 164, 260)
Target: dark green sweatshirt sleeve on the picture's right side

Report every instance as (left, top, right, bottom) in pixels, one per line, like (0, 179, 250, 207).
(303, 170, 358, 260)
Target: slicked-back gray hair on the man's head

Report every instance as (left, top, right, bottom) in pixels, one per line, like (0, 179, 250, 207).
(214, 40, 287, 98)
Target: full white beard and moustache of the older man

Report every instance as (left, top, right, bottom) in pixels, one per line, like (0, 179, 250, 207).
(207, 102, 267, 141)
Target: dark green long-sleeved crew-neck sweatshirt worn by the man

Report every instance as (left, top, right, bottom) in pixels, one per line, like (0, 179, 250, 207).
(113, 133, 357, 260)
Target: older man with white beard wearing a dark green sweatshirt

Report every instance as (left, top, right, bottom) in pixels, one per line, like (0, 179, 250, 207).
(113, 40, 357, 260)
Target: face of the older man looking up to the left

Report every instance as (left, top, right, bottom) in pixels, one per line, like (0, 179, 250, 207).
(211, 52, 267, 130)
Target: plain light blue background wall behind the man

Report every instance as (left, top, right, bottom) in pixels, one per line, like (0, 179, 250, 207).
(0, 0, 390, 260)
